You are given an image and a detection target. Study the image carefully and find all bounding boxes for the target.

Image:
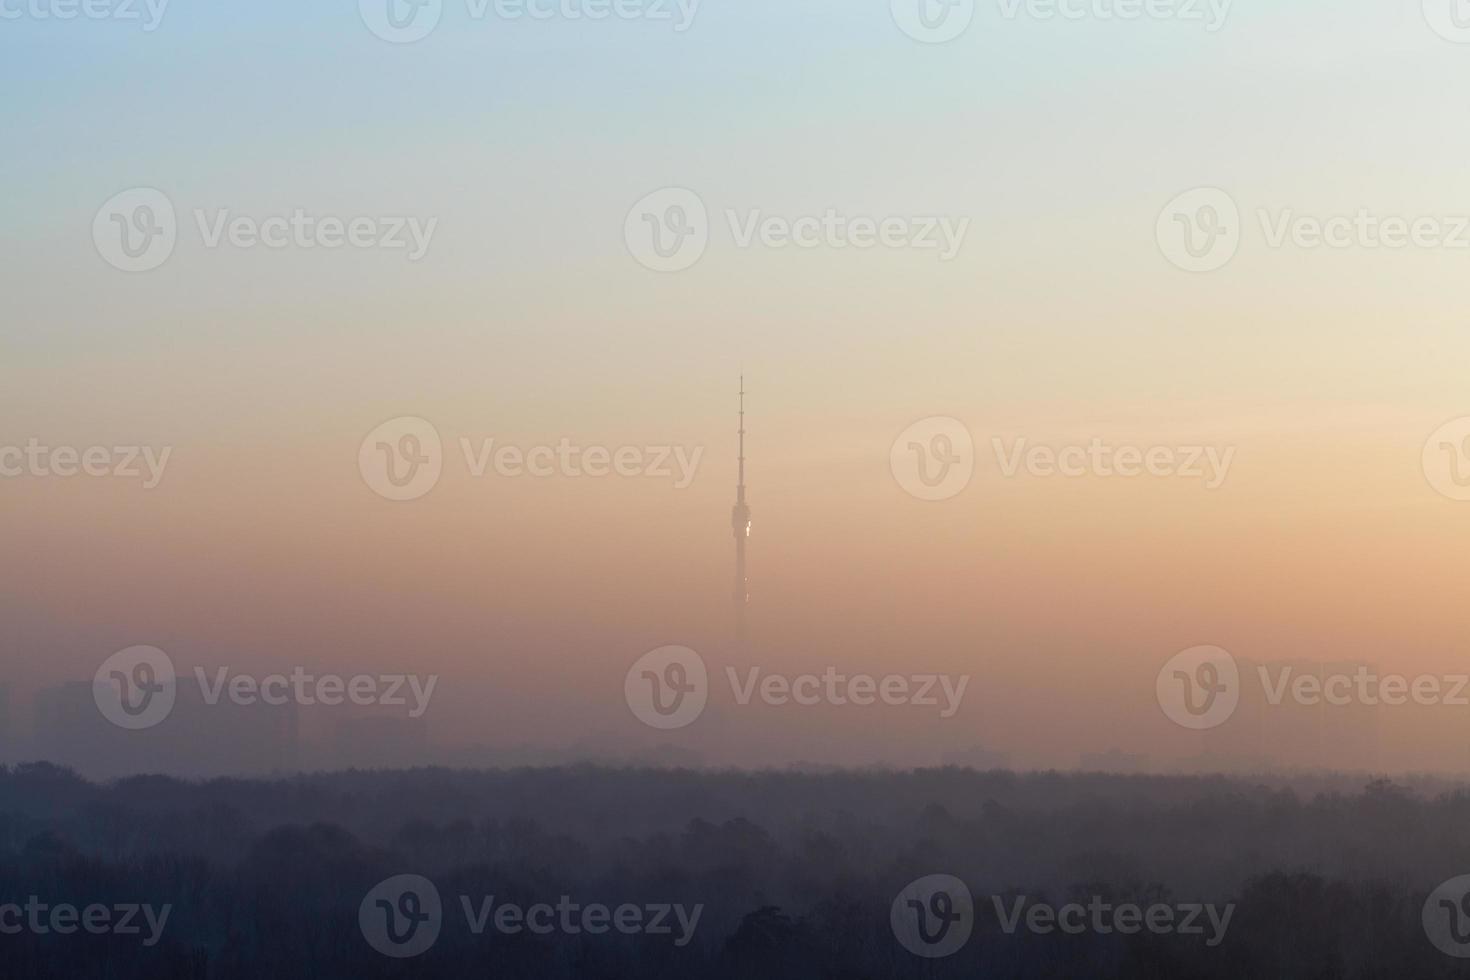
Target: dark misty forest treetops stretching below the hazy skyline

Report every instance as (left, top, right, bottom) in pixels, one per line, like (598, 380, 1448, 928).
(0, 763, 1470, 980)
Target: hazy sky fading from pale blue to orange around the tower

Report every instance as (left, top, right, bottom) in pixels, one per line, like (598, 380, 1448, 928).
(0, 0, 1470, 770)
